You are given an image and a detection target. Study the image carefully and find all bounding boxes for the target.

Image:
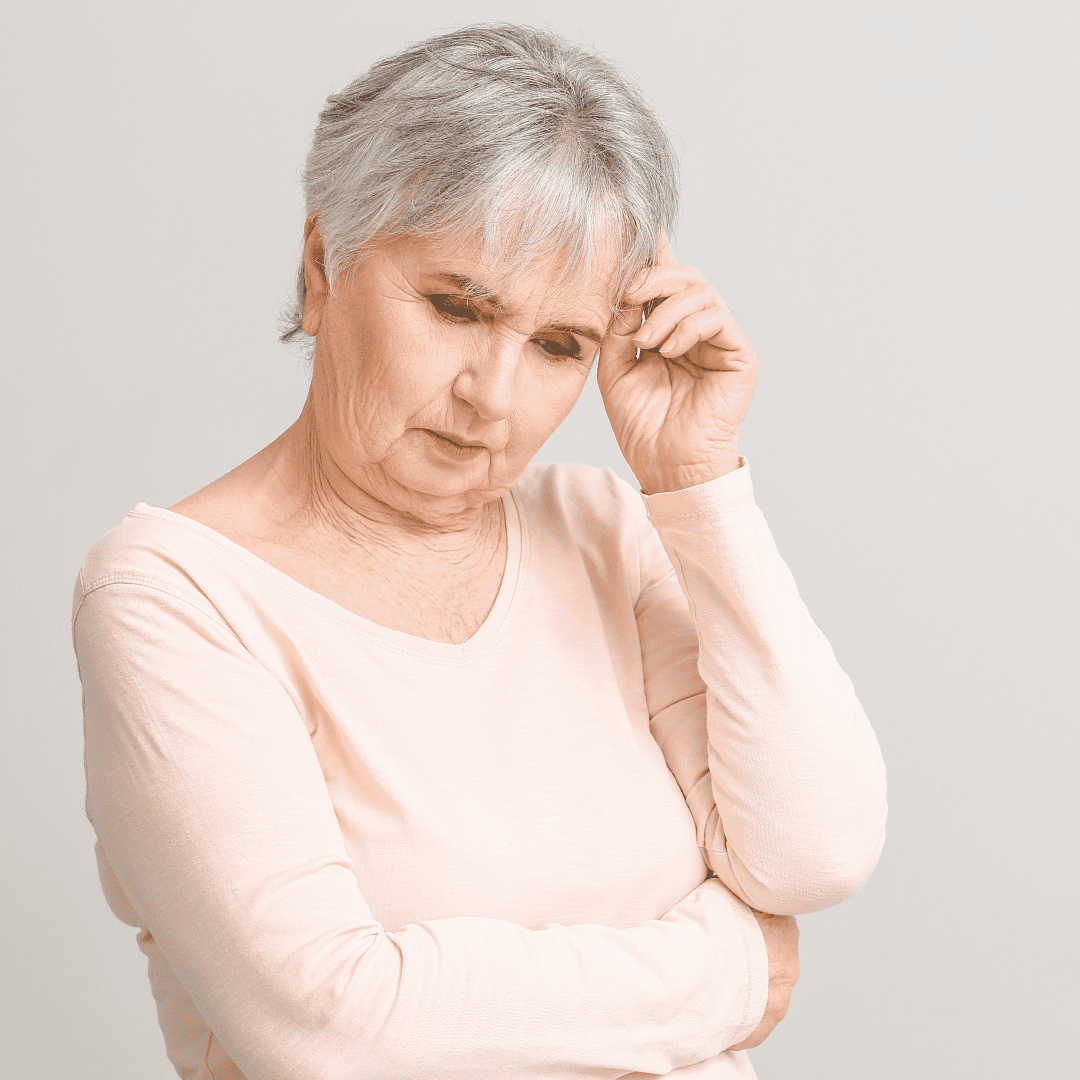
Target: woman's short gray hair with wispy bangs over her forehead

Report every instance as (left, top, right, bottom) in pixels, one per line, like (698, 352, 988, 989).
(281, 23, 678, 341)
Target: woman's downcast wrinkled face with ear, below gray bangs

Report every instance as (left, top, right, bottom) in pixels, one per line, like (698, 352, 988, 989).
(303, 227, 610, 524)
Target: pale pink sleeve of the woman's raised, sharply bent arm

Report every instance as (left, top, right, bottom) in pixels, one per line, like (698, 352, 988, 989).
(636, 461, 886, 914)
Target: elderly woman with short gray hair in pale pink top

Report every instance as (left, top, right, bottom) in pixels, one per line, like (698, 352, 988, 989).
(72, 25, 886, 1080)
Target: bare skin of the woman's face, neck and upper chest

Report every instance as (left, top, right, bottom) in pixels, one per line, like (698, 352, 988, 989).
(165, 217, 618, 643)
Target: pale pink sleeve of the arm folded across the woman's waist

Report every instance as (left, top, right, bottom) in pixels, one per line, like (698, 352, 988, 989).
(73, 581, 768, 1080)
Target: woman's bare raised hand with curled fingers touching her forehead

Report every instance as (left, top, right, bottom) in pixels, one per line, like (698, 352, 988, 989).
(596, 232, 757, 495)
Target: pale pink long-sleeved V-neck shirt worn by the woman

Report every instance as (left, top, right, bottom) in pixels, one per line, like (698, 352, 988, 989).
(72, 462, 886, 1080)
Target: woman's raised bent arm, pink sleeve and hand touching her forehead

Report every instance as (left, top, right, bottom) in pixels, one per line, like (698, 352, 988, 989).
(597, 238, 886, 915)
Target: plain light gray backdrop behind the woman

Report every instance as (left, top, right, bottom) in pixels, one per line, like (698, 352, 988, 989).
(0, 0, 1080, 1080)
